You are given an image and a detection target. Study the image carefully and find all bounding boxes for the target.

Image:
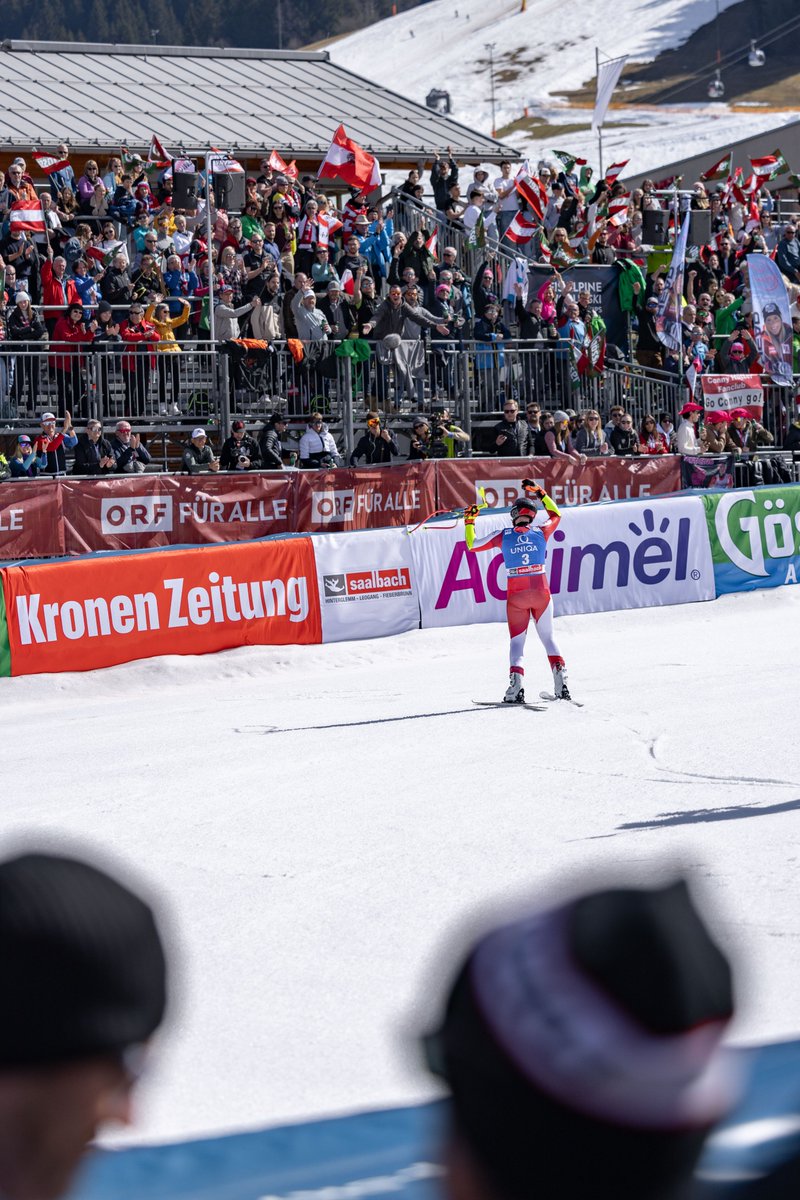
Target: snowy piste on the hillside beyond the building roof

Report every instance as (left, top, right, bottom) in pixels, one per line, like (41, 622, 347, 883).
(329, 0, 796, 173)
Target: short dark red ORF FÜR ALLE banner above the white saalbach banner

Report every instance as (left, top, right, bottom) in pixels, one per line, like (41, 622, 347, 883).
(295, 462, 437, 533)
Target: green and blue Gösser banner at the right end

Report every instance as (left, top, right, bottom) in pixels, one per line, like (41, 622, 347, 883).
(702, 484, 800, 596)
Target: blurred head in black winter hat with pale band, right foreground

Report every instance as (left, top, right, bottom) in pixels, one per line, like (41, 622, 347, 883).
(426, 881, 736, 1200)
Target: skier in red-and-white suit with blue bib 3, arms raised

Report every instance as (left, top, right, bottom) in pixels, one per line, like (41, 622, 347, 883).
(464, 479, 571, 704)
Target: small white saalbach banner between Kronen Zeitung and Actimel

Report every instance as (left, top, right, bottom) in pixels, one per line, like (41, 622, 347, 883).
(312, 528, 420, 642)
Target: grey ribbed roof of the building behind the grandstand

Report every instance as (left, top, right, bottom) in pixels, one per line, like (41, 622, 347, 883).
(0, 41, 518, 166)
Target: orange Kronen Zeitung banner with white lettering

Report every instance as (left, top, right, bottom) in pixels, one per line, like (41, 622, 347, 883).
(0, 538, 321, 676)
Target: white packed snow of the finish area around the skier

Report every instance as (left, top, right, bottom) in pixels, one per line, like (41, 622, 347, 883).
(0, 590, 800, 1140)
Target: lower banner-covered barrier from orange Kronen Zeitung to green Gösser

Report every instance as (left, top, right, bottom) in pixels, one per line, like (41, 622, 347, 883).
(0, 485, 800, 676)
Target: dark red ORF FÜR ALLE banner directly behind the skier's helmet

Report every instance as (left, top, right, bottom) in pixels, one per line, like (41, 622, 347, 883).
(437, 455, 681, 509)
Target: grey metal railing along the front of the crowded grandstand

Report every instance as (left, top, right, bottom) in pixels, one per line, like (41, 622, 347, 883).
(0, 338, 800, 455)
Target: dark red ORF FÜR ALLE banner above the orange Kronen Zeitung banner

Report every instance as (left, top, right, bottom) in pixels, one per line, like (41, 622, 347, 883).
(60, 472, 295, 554)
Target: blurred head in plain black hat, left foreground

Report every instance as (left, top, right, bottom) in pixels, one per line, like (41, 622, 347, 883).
(0, 853, 167, 1200)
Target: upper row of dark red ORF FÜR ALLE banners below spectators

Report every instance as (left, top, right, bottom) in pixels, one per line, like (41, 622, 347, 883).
(0, 455, 681, 560)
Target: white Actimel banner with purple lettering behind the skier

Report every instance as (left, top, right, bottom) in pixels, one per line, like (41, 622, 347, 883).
(409, 496, 715, 628)
